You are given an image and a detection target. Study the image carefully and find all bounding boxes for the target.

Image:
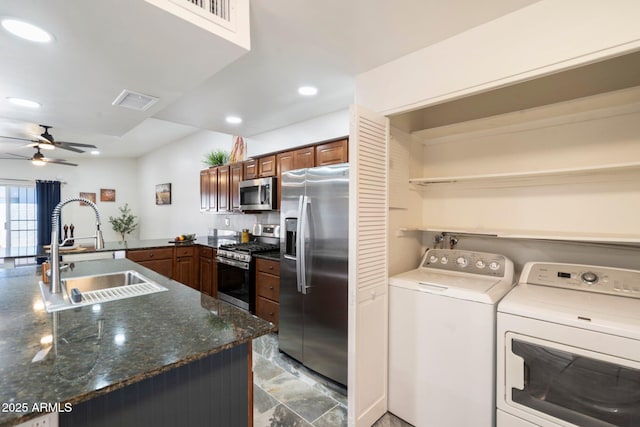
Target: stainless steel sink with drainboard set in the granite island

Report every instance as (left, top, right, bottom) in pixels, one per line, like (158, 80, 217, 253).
(40, 270, 168, 313)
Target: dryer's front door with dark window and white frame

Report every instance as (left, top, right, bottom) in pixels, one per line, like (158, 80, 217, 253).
(506, 334, 640, 427)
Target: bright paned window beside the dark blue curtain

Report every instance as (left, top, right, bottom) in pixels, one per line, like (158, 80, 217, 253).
(0, 185, 37, 254)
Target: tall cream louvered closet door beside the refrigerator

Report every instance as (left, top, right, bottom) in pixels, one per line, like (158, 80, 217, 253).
(348, 106, 389, 426)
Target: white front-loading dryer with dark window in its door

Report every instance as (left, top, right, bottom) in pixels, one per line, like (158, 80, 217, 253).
(496, 263, 640, 427)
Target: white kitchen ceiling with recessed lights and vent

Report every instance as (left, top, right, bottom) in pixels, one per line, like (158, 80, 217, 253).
(0, 0, 537, 158)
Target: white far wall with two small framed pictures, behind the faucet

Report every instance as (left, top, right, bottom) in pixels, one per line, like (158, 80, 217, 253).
(0, 158, 138, 243)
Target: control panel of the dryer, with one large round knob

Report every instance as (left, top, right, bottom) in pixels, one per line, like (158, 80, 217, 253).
(520, 262, 640, 298)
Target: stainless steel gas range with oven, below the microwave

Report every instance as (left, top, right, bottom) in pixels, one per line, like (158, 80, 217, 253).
(216, 242, 279, 313)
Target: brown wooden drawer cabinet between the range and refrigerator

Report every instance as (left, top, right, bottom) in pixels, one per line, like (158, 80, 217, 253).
(256, 258, 280, 330)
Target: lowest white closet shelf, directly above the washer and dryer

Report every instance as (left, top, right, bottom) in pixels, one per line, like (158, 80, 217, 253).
(400, 225, 640, 245)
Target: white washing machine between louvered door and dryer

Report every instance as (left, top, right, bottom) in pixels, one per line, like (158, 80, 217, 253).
(389, 249, 514, 427)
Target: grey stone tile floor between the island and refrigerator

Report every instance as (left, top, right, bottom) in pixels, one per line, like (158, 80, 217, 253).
(253, 335, 410, 427)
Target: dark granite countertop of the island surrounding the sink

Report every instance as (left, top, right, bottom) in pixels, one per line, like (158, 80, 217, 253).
(0, 259, 273, 426)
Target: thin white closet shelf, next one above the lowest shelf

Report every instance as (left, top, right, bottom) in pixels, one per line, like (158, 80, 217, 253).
(409, 162, 640, 186)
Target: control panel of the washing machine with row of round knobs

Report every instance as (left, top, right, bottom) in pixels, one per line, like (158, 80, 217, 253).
(420, 249, 511, 277)
